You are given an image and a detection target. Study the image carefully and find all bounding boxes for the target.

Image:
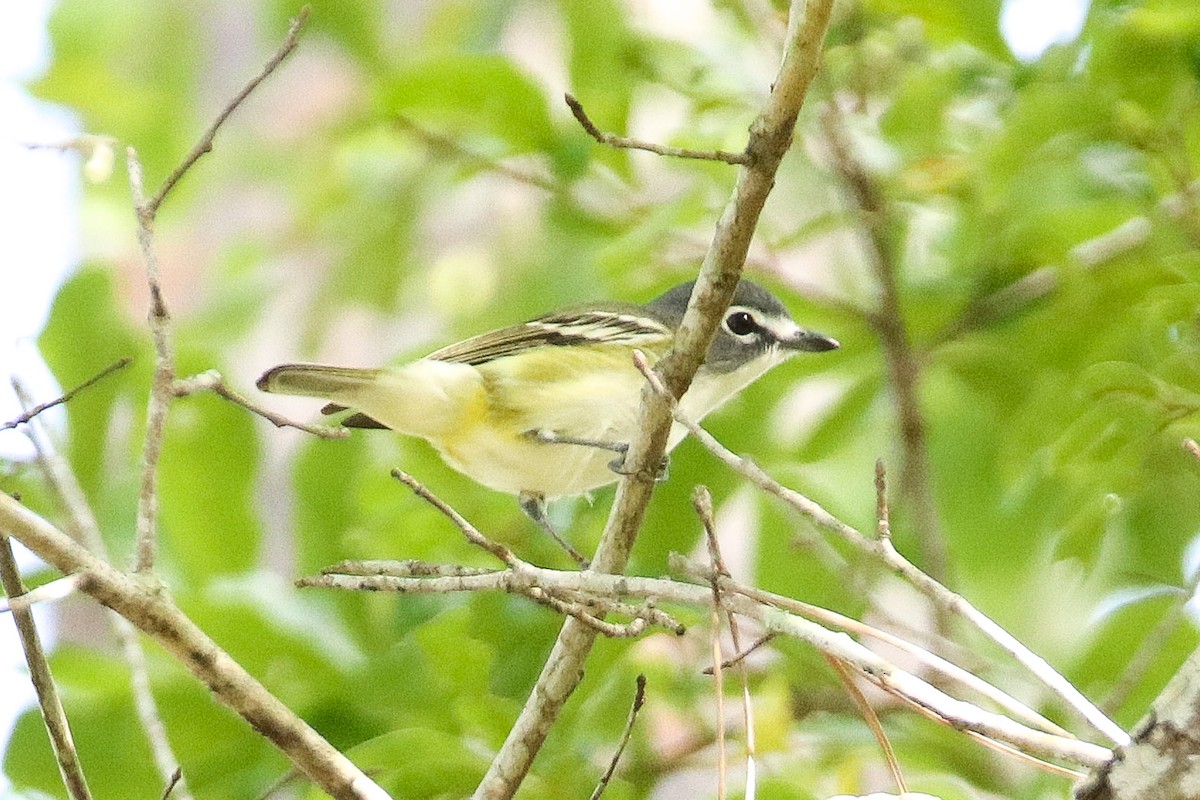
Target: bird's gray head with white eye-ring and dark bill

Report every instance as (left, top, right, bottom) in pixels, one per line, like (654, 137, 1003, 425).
(647, 279, 839, 373)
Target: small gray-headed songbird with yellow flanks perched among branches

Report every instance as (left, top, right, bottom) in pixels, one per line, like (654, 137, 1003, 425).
(258, 281, 838, 563)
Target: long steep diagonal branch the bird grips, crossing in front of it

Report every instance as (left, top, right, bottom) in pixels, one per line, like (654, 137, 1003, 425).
(474, 0, 833, 800)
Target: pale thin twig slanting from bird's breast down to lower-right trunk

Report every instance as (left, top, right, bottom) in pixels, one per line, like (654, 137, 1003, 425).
(634, 351, 1129, 745)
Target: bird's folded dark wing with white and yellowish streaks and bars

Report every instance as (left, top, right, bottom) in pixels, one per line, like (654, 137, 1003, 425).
(426, 306, 672, 366)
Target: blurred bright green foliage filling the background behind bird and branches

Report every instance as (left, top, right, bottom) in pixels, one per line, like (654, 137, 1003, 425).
(5, 0, 1200, 798)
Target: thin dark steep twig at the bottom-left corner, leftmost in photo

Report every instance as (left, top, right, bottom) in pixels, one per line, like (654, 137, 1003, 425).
(0, 532, 91, 800)
